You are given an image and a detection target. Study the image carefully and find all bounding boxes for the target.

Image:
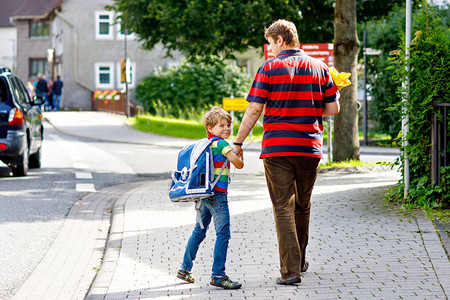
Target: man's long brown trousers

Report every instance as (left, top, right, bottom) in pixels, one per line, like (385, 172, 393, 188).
(264, 156, 320, 279)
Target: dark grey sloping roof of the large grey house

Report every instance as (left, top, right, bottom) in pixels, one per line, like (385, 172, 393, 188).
(8, 0, 63, 19)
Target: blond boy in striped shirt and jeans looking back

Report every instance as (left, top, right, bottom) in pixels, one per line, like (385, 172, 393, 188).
(177, 106, 244, 289)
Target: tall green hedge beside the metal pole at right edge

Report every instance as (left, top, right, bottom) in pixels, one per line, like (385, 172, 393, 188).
(393, 9, 450, 207)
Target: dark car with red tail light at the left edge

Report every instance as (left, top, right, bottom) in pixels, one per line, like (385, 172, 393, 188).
(0, 67, 44, 176)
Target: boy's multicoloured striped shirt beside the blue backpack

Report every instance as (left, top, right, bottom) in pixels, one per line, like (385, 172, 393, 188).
(208, 134, 232, 193)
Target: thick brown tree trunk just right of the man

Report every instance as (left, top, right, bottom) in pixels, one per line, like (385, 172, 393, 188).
(333, 0, 359, 161)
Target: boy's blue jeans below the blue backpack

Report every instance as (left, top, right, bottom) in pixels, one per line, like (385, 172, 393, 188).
(181, 191, 231, 278)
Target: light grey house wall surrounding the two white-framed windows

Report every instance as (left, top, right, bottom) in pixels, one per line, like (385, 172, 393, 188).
(55, 0, 181, 110)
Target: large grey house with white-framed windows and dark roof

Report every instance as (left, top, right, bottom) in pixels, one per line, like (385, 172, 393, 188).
(11, 0, 181, 110)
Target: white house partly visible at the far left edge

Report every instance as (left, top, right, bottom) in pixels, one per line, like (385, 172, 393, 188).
(0, 0, 21, 70)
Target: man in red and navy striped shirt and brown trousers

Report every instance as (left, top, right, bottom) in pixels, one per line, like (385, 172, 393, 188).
(234, 20, 340, 285)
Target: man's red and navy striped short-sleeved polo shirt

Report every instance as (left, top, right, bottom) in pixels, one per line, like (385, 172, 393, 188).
(247, 49, 339, 158)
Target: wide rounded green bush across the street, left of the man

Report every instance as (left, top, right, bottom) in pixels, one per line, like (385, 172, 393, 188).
(136, 60, 251, 119)
